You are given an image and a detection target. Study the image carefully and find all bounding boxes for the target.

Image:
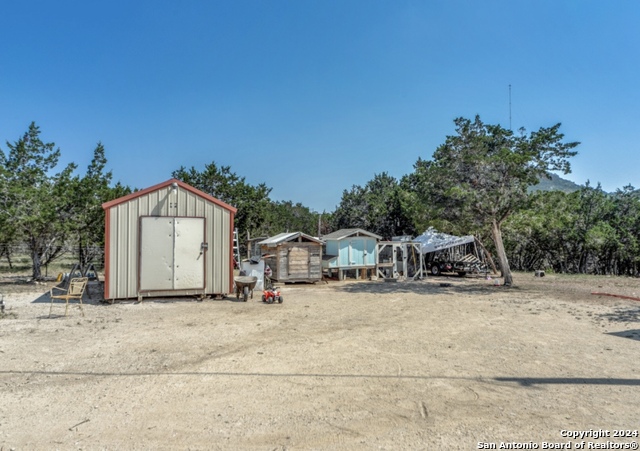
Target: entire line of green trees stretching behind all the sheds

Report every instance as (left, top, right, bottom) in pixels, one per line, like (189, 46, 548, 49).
(0, 116, 640, 285)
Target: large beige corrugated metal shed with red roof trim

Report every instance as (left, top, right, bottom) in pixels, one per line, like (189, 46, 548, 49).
(102, 179, 236, 300)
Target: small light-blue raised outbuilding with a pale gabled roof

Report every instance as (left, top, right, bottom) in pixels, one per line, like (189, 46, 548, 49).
(322, 229, 382, 280)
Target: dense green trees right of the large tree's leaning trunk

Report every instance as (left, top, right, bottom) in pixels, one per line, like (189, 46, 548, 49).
(505, 183, 640, 276)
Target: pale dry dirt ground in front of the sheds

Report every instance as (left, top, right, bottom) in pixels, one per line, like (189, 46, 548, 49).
(0, 274, 640, 450)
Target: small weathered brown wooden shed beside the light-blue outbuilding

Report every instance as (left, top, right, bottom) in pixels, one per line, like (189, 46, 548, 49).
(260, 232, 323, 282)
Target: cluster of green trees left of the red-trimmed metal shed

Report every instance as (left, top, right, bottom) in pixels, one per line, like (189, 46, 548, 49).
(0, 123, 131, 280)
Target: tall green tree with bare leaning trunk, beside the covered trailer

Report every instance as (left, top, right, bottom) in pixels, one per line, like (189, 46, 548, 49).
(415, 116, 578, 286)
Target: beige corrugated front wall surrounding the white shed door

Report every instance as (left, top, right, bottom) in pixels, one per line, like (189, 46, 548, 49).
(105, 185, 232, 299)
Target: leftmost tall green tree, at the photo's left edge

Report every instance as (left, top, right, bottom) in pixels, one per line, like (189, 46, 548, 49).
(0, 122, 75, 280)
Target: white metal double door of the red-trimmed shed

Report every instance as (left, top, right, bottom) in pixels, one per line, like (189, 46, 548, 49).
(139, 217, 205, 291)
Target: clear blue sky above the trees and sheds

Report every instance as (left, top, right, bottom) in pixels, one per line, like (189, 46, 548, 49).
(0, 0, 640, 211)
